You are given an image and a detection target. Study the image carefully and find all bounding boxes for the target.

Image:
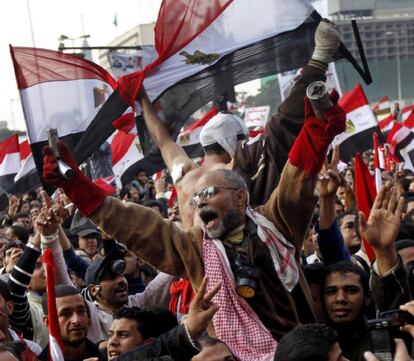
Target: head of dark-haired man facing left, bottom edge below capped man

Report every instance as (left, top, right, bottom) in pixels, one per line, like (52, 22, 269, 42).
(107, 307, 177, 361)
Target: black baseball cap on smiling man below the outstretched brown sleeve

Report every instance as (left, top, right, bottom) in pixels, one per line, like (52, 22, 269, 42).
(85, 249, 125, 286)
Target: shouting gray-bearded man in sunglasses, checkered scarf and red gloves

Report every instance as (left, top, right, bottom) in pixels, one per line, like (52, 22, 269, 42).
(43, 72, 346, 360)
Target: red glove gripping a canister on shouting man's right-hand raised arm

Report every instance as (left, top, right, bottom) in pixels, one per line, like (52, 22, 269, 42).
(289, 90, 346, 175)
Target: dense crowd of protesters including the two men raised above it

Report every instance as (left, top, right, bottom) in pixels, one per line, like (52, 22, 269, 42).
(0, 21, 414, 361)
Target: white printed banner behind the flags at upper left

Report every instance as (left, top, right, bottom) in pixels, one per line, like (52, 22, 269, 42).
(108, 45, 157, 79)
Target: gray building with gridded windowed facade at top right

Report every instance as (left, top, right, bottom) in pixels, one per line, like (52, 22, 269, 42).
(332, 0, 414, 104)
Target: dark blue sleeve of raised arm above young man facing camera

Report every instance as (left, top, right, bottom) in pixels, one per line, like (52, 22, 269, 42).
(315, 221, 350, 266)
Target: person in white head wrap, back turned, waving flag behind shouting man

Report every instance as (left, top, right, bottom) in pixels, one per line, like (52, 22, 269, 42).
(140, 19, 340, 229)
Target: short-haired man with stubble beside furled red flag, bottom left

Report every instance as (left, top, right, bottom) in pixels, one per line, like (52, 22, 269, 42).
(39, 285, 102, 361)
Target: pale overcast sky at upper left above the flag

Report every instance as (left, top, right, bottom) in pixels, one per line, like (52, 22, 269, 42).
(0, 0, 161, 130)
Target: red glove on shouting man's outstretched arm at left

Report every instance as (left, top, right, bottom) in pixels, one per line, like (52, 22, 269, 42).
(43, 142, 110, 217)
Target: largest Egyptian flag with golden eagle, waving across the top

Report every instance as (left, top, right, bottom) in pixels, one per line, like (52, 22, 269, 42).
(76, 0, 369, 175)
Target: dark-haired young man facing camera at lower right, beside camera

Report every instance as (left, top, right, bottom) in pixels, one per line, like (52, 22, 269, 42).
(321, 261, 372, 361)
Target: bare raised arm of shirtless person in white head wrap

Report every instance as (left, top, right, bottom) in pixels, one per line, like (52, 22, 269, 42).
(140, 90, 197, 173)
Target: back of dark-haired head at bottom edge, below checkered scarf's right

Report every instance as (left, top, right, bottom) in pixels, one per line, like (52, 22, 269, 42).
(275, 324, 349, 361)
